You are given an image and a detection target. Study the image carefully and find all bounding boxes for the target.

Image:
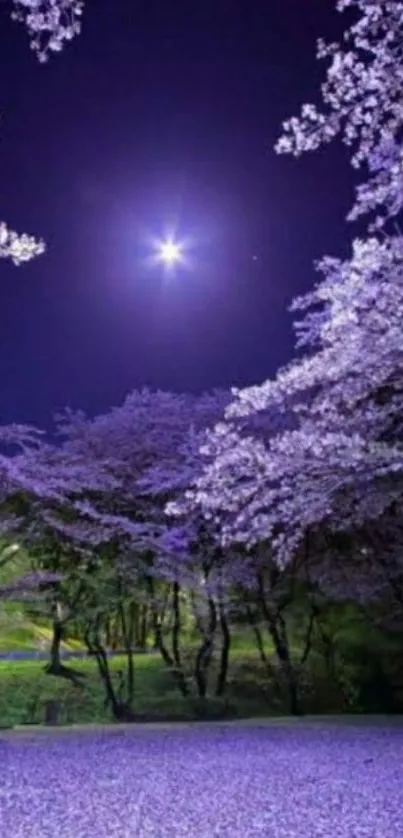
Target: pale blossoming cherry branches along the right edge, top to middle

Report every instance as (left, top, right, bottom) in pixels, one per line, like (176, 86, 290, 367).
(175, 0, 403, 584)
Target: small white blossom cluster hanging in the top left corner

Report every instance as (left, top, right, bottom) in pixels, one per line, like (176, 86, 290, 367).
(11, 0, 84, 62)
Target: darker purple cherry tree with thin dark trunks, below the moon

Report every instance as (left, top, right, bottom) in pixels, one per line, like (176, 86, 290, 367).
(10, 389, 235, 715)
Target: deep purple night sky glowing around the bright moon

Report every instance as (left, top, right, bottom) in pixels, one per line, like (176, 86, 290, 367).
(0, 0, 353, 427)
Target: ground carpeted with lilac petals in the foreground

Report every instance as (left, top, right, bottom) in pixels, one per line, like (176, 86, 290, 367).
(0, 723, 403, 838)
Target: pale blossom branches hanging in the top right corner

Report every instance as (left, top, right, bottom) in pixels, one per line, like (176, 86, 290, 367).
(276, 0, 403, 229)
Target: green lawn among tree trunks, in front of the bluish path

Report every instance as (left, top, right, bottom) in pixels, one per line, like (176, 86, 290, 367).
(0, 649, 290, 727)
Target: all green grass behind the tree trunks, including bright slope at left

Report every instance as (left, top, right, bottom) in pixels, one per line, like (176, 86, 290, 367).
(0, 607, 386, 727)
